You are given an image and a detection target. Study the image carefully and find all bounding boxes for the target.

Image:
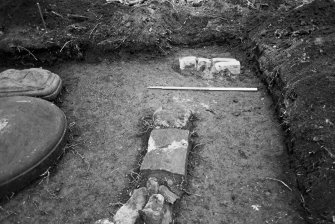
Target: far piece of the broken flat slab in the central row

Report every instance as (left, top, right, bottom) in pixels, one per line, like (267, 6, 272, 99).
(148, 128, 189, 152)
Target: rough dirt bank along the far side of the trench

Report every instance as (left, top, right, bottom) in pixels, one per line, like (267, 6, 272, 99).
(0, 0, 245, 65)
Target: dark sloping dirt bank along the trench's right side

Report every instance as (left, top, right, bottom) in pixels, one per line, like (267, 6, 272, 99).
(251, 0, 335, 223)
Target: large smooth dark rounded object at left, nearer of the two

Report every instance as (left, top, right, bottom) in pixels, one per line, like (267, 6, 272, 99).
(0, 96, 66, 196)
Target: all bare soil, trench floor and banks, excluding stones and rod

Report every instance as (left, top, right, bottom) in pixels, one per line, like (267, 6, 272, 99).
(0, 0, 335, 223)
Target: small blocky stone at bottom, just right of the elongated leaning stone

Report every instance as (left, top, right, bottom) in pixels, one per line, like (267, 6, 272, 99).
(140, 194, 164, 224)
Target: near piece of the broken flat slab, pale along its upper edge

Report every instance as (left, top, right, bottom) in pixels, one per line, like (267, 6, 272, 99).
(141, 137, 188, 176)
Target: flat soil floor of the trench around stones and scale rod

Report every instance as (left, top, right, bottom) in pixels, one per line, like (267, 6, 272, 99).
(0, 45, 303, 224)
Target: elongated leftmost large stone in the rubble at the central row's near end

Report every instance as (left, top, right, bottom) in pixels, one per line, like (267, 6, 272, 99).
(113, 187, 148, 224)
